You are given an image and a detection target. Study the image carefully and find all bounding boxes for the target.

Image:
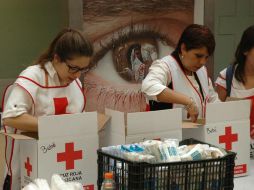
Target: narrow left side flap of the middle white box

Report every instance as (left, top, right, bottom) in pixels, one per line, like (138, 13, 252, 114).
(105, 109, 125, 136)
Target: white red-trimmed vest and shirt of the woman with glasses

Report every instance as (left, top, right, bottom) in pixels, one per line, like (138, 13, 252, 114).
(2, 62, 85, 190)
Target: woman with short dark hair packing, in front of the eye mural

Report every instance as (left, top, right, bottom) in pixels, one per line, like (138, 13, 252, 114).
(142, 24, 218, 122)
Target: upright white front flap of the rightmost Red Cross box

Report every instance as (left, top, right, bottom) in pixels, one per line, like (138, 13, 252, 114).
(206, 100, 251, 124)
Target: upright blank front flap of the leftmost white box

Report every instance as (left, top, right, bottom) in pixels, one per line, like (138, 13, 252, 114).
(38, 112, 98, 139)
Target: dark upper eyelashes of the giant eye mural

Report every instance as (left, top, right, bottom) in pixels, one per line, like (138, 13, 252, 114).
(92, 24, 175, 66)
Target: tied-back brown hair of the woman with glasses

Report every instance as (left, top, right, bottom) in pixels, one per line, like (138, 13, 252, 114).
(35, 28, 93, 68)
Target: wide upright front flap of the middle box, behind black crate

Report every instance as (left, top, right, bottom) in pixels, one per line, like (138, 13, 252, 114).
(127, 108, 182, 135)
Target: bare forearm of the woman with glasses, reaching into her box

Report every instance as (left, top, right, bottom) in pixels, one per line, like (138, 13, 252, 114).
(3, 113, 38, 132)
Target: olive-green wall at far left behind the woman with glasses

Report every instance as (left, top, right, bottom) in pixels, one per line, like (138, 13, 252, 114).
(0, 0, 69, 187)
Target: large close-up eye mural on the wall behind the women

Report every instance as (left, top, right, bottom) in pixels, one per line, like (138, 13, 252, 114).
(83, 0, 194, 112)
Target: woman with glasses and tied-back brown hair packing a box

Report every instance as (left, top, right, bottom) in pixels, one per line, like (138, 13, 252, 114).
(2, 29, 93, 190)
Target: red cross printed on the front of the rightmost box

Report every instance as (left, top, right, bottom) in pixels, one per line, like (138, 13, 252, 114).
(219, 126, 238, 150)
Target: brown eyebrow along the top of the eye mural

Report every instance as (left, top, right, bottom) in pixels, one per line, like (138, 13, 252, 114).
(83, 0, 194, 21)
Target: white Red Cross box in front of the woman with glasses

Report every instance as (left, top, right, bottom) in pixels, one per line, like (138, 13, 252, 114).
(0, 112, 98, 190)
